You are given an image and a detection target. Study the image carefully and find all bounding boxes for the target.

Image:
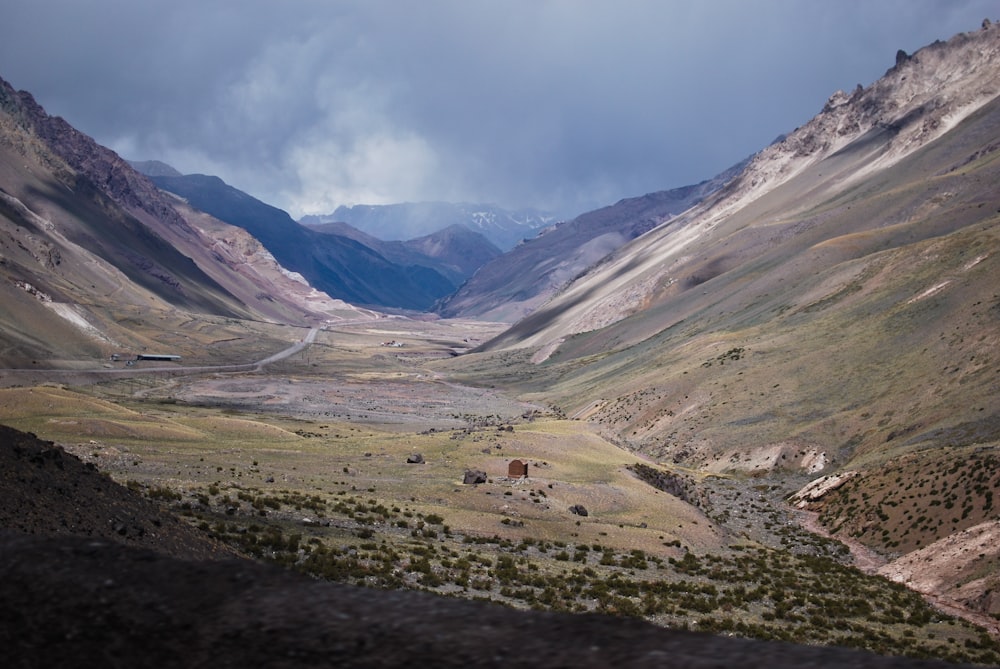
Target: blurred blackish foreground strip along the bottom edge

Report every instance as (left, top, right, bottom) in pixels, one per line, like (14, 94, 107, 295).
(0, 533, 972, 669)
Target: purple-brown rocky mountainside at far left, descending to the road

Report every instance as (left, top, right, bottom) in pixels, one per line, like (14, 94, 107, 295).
(0, 75, 370, 366)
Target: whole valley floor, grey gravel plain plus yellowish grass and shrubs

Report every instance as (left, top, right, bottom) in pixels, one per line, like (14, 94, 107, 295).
(0, 319, 1000, 663)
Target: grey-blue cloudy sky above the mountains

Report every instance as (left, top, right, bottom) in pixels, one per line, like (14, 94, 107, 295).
(0, 0, 1000, 218)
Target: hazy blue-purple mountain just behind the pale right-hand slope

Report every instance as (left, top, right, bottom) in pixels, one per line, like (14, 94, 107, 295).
(435, 163, 744, 322)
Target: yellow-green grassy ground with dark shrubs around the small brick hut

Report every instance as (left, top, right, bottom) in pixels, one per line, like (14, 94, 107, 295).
(0, 356, 1000, 662)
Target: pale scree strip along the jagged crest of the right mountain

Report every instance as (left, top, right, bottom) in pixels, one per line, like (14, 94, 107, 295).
(482, 20, 1000, 352)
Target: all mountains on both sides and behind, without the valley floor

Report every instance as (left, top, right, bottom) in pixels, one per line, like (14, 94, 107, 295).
(0, 21, 1000, 648)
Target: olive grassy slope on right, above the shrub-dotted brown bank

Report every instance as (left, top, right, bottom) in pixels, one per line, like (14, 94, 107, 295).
(460, 94, 1000, 464)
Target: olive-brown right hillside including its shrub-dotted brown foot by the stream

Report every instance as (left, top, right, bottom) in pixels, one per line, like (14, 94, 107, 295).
(436, 86, 1000, 614)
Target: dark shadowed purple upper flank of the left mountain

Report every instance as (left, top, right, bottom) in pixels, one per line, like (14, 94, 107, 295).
(0, 81, 242, 315)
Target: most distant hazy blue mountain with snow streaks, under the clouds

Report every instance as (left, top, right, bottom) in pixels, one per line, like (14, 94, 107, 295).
(299, 202, 555, 251)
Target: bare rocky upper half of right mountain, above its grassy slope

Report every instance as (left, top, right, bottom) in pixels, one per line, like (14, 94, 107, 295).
(476, 25, 1000, 346)
